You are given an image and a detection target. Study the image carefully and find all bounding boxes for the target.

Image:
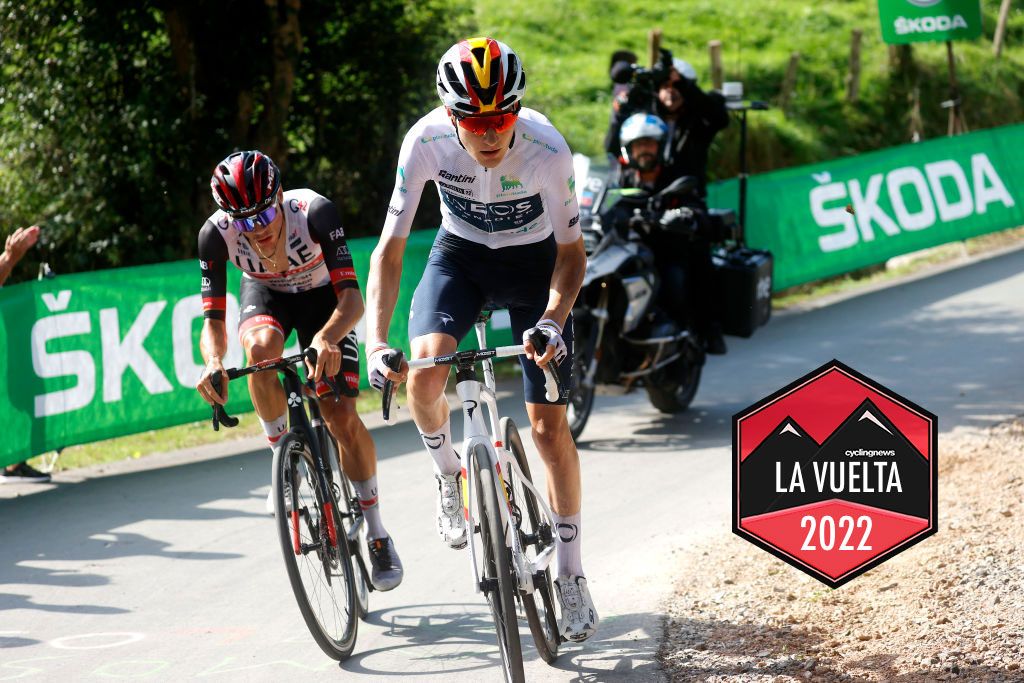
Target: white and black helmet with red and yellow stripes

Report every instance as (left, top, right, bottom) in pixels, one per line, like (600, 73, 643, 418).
(437, 37, 526, 116)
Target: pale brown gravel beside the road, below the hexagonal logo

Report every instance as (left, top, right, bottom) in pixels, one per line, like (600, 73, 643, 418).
(658, 418, 1024, 682)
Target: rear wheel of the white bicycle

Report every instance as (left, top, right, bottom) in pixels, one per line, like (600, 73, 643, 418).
(498, 418, 561, 664)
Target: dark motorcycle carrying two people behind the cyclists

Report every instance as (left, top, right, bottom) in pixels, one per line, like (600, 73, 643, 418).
(567, 167, 736, 438)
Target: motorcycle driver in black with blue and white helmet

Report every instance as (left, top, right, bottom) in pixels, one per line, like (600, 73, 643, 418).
(615, 114, 726, 355)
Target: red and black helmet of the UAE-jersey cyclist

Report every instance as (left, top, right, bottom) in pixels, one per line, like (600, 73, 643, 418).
(210, 150, 281, 216)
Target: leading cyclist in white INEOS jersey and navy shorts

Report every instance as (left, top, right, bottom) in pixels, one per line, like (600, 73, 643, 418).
(367, 38, 598, 641)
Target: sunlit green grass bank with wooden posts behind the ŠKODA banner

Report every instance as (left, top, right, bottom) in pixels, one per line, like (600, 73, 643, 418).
(476, 0, 1024, 178)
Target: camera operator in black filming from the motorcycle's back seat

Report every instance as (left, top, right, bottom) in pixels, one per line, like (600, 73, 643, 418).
(604, 49, 729, 197)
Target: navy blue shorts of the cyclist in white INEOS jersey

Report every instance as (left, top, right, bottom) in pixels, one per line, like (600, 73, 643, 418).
(409, 228, 572, 404)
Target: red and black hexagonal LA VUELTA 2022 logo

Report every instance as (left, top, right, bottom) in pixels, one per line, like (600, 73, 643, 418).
(732, 360, 938, 588)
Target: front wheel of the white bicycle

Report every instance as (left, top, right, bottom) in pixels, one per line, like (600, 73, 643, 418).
(472, 443, 526, 683)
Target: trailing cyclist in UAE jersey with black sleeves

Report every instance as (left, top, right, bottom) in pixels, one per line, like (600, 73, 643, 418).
(197, 151, 402, 591)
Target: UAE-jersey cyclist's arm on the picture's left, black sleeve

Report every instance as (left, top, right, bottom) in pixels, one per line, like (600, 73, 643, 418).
(196, 221, 227, 404)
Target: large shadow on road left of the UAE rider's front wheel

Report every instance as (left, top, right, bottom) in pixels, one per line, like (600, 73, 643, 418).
(0, 453, 270, 614)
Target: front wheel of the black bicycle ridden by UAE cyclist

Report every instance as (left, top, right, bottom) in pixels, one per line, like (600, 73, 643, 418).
(272, 431, 358, 661)
